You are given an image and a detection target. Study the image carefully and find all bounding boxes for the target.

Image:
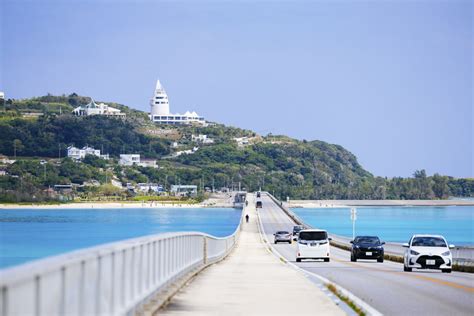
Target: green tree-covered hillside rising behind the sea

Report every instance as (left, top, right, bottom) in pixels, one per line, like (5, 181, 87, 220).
(0, 94, 474, 202)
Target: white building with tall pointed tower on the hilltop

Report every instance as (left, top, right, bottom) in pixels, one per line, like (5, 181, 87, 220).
(150, 80, 206, 125)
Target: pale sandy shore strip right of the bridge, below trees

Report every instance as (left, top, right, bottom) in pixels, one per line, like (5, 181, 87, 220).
(289, 200, 474, 208)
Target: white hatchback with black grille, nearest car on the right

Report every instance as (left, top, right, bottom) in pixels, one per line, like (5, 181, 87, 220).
(403, 235, 454, 273)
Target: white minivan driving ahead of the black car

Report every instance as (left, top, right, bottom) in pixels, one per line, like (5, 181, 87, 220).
(296, 229, 331, 262)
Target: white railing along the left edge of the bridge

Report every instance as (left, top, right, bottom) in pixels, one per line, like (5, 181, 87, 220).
(0, 212, 243, 316)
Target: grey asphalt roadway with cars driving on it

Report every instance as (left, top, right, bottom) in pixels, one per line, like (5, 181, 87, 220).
(258, 195, 474, 315)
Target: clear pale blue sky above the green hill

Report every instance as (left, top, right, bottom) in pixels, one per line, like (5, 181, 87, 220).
(0, 0, 474, 177)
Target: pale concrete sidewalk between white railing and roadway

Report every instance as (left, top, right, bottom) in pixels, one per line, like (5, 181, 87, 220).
(158, 194, 345, 315)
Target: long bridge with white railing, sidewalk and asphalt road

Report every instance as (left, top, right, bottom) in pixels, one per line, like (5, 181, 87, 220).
(0, 194, 474, 316)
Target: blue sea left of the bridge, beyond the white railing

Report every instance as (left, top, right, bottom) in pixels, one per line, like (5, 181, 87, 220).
(0, 208, 241, 268)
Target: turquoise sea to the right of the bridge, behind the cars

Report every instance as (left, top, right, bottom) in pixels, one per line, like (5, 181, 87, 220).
(293, 206, 474, 245)
